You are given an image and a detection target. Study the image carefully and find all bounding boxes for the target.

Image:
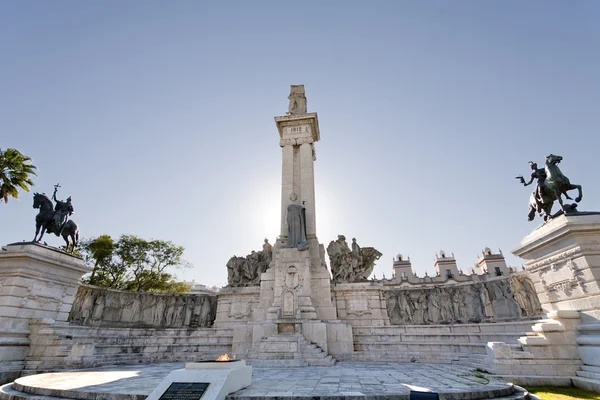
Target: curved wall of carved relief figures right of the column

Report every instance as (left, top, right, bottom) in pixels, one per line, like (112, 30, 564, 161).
(386, 273, 542, 325)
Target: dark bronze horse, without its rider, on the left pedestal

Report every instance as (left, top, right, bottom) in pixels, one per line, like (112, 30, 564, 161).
(33, 193, 79, 253)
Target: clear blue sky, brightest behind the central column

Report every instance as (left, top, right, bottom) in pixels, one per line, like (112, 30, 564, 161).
(0, 0, 600, 285)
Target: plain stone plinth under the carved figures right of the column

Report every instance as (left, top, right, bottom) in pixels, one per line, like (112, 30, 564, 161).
(333, 282, 390, 326)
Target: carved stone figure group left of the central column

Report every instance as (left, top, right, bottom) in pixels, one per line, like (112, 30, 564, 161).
(227, 239, 273, 287)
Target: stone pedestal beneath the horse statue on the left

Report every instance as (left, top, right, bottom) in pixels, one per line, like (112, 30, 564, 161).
(0, 243, 90, 383)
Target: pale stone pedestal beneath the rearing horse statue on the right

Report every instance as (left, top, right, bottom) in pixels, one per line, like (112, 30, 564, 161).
(513, 214, 600, 323)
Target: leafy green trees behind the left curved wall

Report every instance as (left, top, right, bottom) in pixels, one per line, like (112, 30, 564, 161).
(81, 235, 190, 293)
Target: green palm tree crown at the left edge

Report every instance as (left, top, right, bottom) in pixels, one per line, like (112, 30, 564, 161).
(0, 149, 37, 203)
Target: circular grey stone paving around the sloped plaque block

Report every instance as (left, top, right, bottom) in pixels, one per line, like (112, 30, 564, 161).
(0, 362, 514, 400)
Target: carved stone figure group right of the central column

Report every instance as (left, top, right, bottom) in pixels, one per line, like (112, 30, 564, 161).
(327, 235, 382, 283)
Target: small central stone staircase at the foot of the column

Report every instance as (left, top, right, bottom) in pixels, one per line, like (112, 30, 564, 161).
(247, 333, 336, 368)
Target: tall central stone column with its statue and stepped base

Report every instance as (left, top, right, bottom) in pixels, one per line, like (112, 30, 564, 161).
(215, 85, 352, 366)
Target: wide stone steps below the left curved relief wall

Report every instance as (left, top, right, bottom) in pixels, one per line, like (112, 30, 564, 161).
(23, 324, 233, 375)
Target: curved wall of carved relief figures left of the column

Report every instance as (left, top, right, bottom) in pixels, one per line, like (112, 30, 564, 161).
(68, 285, 217, 328)
